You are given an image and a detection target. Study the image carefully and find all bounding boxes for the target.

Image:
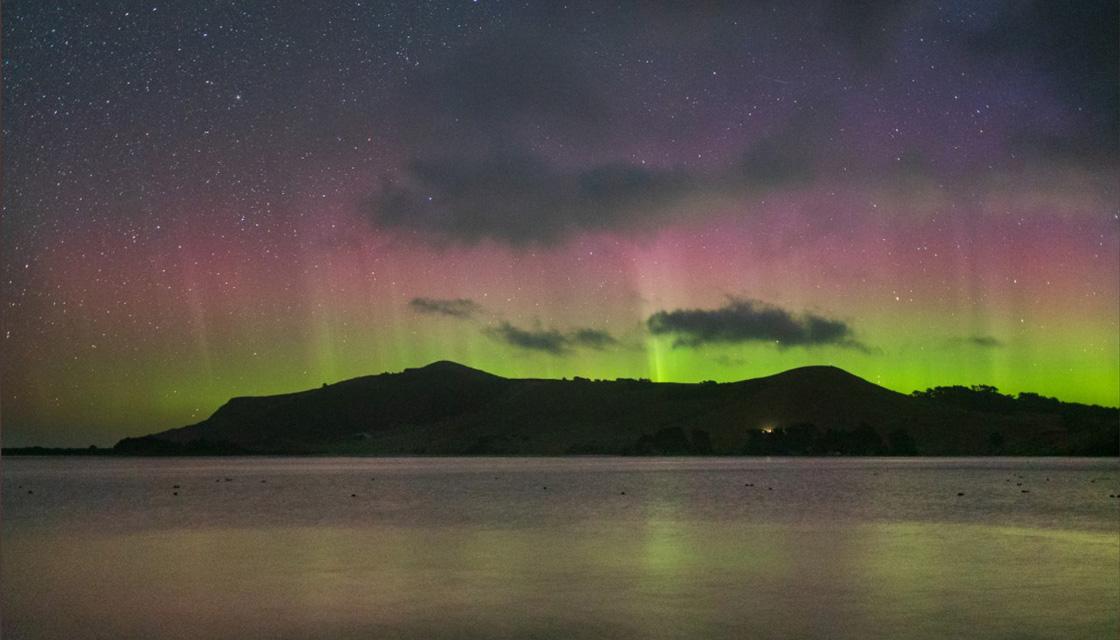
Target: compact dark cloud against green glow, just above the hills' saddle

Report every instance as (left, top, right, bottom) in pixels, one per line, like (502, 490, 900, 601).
(646, 297, 867, 351)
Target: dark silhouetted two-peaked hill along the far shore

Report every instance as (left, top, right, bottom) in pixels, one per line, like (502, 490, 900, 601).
(106, 361, 1120, 455)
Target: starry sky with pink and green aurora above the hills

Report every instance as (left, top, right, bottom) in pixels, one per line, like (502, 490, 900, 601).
(0, 0, 1120, 446)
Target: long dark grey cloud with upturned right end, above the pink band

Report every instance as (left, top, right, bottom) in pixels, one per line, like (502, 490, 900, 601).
(366, 100, 838, 245)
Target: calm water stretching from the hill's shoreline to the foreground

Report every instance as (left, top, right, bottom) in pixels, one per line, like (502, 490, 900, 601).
(0, 458, 1120, 639)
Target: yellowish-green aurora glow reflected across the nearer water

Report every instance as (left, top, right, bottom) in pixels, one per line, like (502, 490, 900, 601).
(0, 520, 1120, 638)
